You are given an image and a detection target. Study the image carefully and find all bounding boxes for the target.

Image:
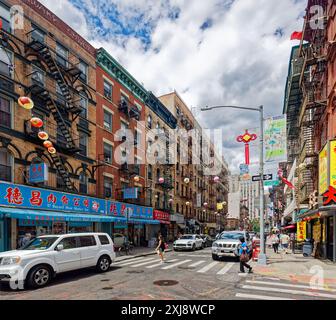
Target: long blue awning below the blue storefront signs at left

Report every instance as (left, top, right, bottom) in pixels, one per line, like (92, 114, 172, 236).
(0, 207, 118, 222)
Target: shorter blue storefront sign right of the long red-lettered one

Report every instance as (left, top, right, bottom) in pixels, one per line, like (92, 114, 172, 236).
(107, 201, 153, 219)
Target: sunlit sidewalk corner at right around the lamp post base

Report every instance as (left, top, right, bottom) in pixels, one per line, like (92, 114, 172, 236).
(251, 248, 336, 288)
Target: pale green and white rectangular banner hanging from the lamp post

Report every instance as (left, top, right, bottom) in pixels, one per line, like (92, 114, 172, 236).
(264, 115, 287, 162)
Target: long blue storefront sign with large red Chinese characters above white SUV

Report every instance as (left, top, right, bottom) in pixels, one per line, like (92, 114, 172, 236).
(0, 182, 105, 214)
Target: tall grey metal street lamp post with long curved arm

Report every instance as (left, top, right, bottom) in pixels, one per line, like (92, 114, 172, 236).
(201, 106, 267, 265)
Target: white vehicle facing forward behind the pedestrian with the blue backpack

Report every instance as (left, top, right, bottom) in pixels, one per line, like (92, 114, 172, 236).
(212, 231, 252, 260)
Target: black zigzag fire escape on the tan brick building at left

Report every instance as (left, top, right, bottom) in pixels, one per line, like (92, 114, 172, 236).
(26, 37, 82, 191)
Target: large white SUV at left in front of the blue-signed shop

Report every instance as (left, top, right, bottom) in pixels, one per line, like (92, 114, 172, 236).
(0, 232, 115, 289)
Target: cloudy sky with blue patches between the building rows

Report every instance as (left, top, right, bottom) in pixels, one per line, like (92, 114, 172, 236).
(40, 0, 307, 173)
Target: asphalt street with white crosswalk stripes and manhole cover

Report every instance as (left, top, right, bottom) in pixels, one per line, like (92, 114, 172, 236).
(0, 248, 336, 300)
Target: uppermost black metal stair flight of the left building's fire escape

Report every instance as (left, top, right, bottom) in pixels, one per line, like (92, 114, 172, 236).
(30, 40, 82, 115)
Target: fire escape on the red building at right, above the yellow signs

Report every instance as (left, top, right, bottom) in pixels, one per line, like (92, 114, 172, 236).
(298, 3, 327, 204)
